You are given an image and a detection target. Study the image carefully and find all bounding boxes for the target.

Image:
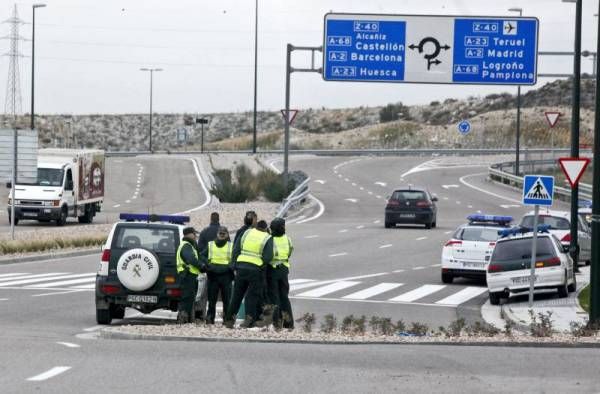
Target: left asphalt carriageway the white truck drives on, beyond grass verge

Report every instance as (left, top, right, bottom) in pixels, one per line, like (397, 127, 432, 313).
(0, 155, 206, 232)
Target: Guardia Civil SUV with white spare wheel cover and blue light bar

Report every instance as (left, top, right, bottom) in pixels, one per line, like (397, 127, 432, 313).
(96, 214, 189, 324)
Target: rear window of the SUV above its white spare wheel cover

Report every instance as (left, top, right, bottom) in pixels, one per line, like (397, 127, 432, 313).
(112, 226, 178, 253)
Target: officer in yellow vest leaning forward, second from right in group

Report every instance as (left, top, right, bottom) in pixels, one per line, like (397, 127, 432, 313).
(225, 221, 273, 328)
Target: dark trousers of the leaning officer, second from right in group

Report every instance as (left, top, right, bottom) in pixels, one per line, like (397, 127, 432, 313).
(227, 263, 264, 321)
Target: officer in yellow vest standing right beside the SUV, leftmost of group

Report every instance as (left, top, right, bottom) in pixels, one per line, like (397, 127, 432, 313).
(177, 227, 206, 324)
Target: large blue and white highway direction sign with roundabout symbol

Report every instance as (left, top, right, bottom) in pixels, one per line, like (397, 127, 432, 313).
(323, 13, 539, 85)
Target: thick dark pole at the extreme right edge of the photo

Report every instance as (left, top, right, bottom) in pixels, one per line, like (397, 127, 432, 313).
(589, 0, 600, 324)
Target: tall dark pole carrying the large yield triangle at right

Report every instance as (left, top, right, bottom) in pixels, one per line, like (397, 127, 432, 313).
(569, 0, 582, 272)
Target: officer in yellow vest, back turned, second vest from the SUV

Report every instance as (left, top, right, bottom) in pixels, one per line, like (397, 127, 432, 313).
(201, 226, 233, 324)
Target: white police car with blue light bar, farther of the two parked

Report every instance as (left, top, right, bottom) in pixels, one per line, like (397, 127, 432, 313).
(442, 214, 513, 283)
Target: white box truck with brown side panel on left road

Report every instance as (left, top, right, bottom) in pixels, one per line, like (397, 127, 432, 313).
(7, 149, 104, 226)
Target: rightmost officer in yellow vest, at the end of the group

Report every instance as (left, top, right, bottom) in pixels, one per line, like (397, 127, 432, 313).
(267, 218, 294, 329)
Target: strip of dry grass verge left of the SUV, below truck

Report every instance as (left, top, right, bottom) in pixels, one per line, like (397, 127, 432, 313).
(0, 235, 106, 256)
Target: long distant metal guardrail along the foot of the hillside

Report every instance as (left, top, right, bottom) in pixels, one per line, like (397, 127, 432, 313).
(106, 148, 580, 157)
